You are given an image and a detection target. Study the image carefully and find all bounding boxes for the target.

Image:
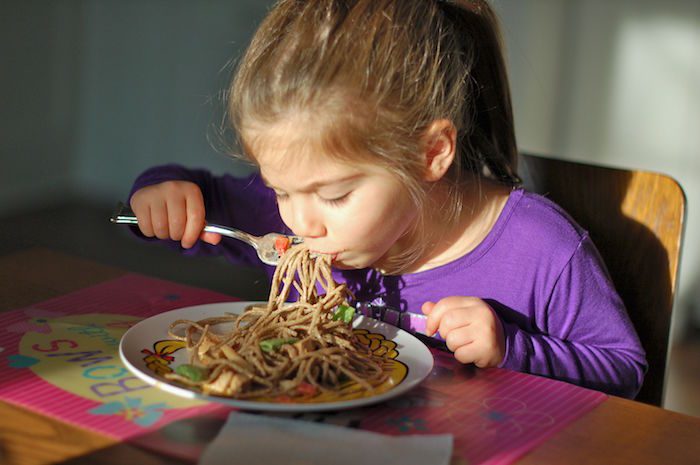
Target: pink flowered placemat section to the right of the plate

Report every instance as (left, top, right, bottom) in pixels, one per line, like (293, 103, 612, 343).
(361, 350, 607, 465)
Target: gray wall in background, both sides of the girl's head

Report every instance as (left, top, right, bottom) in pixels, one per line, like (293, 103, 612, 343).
(0, 0, 700, 334)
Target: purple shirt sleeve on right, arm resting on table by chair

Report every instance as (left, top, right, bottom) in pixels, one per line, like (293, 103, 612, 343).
(501, 235, 647, 398)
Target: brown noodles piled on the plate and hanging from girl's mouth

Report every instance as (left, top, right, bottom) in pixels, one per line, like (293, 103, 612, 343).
(166, 244, 388, 399)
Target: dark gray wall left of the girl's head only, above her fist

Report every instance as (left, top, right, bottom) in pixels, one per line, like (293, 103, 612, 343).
(0, 0, 267, 215)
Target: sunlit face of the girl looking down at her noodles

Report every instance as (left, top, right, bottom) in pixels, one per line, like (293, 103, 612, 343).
(249, 127, 418, 268)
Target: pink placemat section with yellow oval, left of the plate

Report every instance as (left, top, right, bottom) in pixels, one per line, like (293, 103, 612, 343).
(0, 274, 235, 440)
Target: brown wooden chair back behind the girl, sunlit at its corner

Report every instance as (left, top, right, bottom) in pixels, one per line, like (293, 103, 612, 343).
(518, 154, 686, 406)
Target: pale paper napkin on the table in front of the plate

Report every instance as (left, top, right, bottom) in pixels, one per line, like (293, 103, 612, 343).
(199, 412, 453, 465)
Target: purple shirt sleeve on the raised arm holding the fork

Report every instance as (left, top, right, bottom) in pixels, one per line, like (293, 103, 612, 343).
(129, 164, 289, 268)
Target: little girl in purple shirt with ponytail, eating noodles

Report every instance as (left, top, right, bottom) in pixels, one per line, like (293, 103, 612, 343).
(130, 0, 646, 397)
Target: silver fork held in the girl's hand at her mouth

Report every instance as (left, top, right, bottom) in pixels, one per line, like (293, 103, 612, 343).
(110, 202, 304, 266)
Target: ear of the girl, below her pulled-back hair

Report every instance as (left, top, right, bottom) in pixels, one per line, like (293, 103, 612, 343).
(423, 119, 457, 182)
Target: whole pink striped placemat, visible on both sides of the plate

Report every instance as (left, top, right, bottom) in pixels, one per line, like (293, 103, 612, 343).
(0, 275, 607, 464)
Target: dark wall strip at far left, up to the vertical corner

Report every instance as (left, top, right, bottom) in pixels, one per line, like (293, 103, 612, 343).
(0, 1, 82, 214)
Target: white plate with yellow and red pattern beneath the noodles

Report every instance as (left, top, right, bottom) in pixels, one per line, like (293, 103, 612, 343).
(119, 302, 433, 412)
